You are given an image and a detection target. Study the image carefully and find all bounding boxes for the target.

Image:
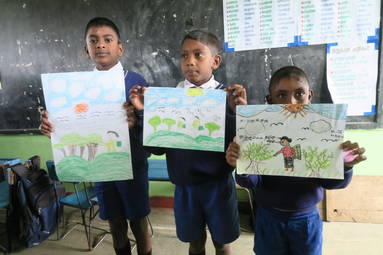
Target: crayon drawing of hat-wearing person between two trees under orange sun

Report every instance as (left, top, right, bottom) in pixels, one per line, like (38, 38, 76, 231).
(236, 104, 347, 179)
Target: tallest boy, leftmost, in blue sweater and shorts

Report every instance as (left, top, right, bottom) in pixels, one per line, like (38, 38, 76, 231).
(40, 17, 152, 255)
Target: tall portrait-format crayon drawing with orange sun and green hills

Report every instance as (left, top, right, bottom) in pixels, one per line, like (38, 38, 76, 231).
(41, 71, 133, 182)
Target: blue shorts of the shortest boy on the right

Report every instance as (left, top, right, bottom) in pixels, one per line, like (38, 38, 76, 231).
(254, 208, 323, 255)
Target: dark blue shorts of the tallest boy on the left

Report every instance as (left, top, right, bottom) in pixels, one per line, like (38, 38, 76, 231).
(95, 163, 150, 220)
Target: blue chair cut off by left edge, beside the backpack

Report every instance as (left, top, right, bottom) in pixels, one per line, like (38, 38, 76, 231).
(0, 158, 21, 252)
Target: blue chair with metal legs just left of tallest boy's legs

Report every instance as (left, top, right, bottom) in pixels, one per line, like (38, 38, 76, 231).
(46, 161, 109, 251)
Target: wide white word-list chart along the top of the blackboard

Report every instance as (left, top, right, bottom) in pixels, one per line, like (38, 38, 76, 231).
(223, 0, 380, 52)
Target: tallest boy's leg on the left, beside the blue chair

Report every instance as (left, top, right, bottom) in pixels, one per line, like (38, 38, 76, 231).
(108, 217, 132, 255)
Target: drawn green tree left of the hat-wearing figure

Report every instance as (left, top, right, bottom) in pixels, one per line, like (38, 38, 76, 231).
(241, 142, 274, 174)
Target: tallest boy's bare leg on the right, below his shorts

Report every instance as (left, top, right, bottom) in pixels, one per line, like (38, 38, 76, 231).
(130, 217, 152, 255)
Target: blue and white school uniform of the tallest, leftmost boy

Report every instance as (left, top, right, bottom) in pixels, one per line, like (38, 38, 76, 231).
(95, 62, 150, 220)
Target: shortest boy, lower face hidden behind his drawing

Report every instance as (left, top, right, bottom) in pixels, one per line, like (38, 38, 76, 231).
(226, 66, 366, 255)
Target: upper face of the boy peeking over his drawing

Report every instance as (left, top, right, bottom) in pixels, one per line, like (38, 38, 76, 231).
(267, 78, 313, 104)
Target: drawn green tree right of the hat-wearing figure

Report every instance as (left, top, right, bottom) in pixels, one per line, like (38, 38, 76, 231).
(303, 147, 334, 177)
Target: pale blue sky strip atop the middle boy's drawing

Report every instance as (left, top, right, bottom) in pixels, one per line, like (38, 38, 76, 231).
(145, 87, 226, 111)
